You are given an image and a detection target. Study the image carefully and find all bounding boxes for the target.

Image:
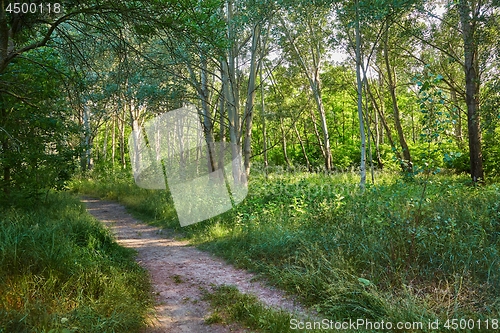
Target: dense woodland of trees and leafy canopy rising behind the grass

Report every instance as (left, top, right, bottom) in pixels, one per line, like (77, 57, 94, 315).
(0, 1, 500, 196)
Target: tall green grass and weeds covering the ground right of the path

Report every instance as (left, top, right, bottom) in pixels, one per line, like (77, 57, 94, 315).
(74, 167, 500, 331)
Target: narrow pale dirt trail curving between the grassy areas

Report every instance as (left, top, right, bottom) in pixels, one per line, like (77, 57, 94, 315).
(82, 197, 304, 333)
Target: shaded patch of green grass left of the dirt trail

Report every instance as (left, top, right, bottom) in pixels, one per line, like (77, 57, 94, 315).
(0, 193, 152, 333)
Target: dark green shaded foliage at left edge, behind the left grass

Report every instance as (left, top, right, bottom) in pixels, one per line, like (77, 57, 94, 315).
(0, 50, 80, 199)
